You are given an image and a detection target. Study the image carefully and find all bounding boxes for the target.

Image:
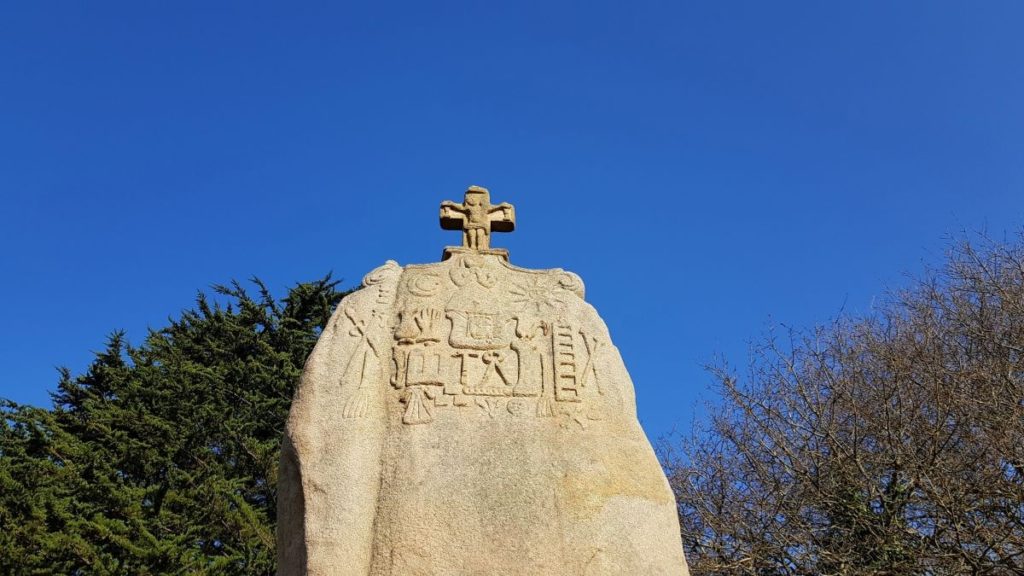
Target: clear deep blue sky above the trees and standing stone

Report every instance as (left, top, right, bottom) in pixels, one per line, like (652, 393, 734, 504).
(0, 1, 1024, 436)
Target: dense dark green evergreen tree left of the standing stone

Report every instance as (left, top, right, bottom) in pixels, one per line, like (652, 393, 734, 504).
(0, 276, 344, 575)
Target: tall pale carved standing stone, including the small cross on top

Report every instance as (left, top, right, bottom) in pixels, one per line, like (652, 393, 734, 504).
(278, 187, 688, 576)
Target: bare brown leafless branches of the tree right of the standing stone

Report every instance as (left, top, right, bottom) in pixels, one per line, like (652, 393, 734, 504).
(663, 233, 1024, 575)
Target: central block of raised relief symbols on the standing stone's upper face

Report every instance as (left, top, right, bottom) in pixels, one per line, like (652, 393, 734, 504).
(385, 254, 600, 426)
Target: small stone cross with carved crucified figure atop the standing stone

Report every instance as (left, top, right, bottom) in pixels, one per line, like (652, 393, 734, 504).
(441, 186, 515, 250)
